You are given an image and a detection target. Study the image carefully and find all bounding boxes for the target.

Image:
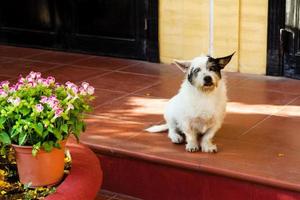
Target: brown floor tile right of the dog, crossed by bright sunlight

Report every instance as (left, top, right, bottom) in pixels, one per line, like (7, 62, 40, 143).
(218, 87, 296, 139)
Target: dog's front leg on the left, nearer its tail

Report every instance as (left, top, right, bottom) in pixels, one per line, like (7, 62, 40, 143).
(183, 122, 199, 152)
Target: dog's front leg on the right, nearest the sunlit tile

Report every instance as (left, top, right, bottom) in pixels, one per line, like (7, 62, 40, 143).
(201, 124, 221, 153)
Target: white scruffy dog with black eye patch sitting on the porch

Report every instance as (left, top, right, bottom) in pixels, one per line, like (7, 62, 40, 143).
(146, 53, 234, 152)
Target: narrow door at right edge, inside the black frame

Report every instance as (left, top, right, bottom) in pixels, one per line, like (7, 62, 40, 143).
(280, 0, 300, 79)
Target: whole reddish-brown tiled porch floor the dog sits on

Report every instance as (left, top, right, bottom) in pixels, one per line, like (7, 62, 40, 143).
(0, 46, 300, 198)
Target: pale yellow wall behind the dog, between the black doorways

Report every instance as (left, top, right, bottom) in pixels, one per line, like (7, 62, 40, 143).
(159, 0, 268, 74)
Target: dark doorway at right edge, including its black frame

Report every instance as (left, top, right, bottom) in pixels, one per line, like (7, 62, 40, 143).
(267, 0, 300, 79)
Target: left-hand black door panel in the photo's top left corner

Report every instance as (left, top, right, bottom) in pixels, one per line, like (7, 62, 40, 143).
(0, 0, 57, 47)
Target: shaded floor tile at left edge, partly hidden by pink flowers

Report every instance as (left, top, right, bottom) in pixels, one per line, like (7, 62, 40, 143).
(0, 59, 57, 78)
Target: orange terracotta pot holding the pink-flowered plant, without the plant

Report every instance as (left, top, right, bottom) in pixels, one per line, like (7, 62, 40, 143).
(12, 141, 66, 187)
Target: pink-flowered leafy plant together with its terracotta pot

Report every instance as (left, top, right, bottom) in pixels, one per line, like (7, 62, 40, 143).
(0, 72, 94, 187)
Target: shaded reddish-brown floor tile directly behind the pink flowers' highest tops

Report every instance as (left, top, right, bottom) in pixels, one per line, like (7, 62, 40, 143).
(45, 65, 106, 82)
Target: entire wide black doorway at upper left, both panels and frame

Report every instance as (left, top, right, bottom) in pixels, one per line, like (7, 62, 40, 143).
(0, 0, 159, 62)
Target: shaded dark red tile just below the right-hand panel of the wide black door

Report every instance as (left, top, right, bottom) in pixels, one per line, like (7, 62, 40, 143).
(73, 56, 139, 70)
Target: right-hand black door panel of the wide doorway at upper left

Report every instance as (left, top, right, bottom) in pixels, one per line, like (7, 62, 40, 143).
(69, 0, 148, 60)
